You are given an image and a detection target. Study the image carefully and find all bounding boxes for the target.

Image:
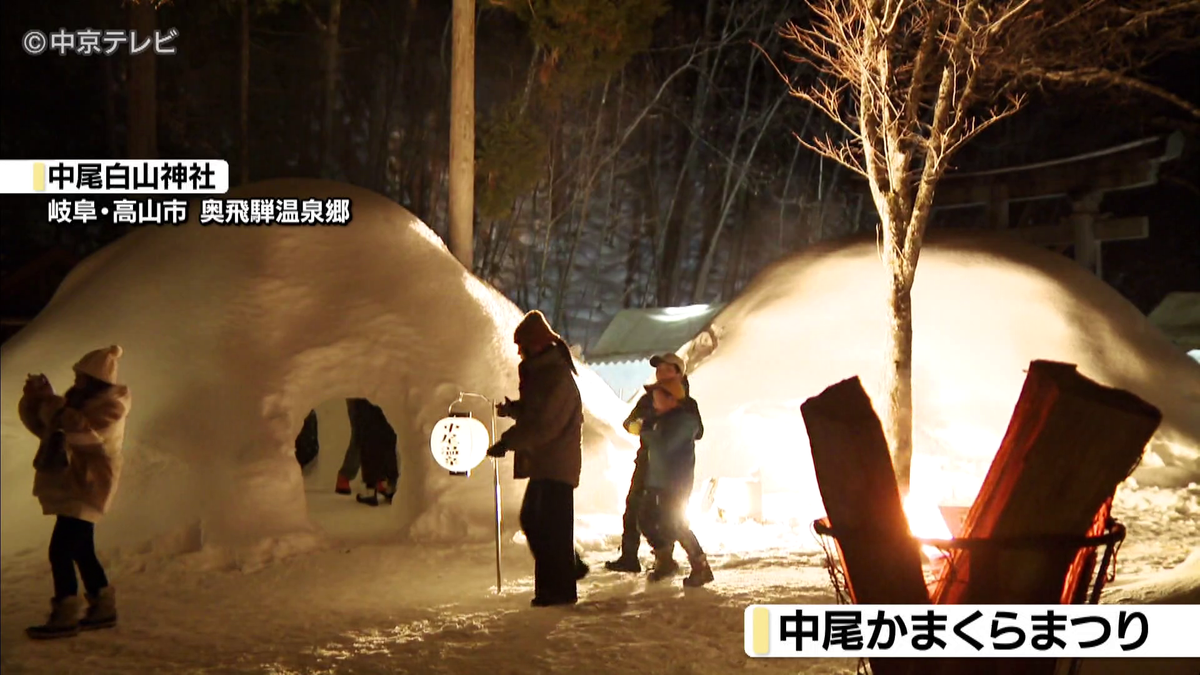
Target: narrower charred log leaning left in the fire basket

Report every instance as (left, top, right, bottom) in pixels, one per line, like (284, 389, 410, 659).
(800, 377, 929, 675)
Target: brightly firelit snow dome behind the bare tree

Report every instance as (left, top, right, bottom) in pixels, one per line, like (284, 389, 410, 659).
(685, 233, 1200, 526)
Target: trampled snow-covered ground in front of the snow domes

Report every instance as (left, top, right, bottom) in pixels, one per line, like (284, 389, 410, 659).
(0, 473, 1200, 675)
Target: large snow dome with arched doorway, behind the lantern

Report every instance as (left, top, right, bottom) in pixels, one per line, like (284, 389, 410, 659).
(0, 180, 631, 557)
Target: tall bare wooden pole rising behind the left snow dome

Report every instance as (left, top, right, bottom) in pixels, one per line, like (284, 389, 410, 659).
(449, 0, 475, 270)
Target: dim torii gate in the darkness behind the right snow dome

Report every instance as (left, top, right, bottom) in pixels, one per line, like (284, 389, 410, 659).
(934, 132, 1183, 275)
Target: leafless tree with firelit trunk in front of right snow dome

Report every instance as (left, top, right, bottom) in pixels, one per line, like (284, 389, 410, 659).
(781, 0, 1200, 495)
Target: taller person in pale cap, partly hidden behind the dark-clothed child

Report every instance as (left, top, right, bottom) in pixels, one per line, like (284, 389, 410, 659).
(605, 353, 704, 573)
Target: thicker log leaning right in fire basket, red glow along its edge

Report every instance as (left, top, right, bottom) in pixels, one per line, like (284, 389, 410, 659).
(934, 360, 1162, 675)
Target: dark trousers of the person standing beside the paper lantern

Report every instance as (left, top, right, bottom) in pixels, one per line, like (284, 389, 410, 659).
(521, 480, 578, 601)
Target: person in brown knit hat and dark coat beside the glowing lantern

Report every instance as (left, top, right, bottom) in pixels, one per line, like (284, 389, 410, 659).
(487, 310, 587, 607)
